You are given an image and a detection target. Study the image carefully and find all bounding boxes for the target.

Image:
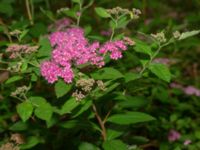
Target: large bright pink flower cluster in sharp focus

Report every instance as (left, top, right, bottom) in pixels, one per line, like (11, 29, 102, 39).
(41, 28, 127, 83)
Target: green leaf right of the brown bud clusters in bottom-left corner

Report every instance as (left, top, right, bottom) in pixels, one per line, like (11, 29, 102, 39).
(20, 136, 41, 150)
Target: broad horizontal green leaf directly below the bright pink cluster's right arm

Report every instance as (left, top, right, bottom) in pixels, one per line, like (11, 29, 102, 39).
(91, 67, 124, 80)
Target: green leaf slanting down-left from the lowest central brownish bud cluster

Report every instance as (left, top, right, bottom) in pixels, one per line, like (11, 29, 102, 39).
(60, 98, 80, 114)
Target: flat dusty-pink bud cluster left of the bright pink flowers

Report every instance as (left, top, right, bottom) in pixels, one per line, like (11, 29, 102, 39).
(6, 44, 38, 59)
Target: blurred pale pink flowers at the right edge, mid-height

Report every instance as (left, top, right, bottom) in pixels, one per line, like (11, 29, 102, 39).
(170, 83, 200, 97)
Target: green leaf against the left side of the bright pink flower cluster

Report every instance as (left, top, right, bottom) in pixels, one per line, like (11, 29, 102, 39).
(38, 38, 52, 57)
